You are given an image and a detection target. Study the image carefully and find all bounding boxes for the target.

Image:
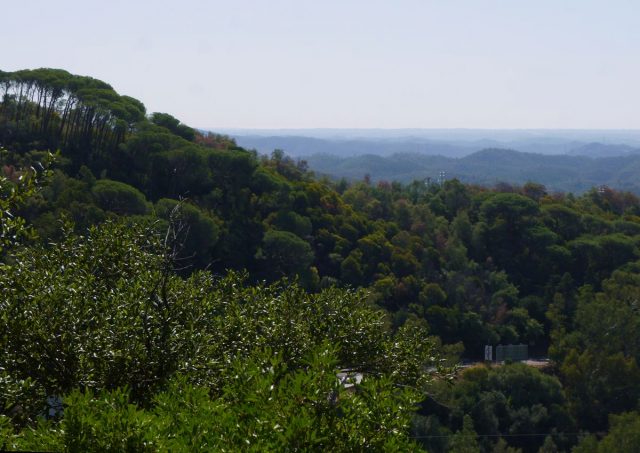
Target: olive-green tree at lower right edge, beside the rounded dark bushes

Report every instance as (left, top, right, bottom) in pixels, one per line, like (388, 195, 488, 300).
(554, 266, 640, 430)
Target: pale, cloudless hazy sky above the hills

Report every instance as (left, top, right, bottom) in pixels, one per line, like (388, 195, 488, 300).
(5, 0, 640, 128)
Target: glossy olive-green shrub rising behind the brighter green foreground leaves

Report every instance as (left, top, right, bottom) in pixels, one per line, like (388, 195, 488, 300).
(0, 222, 439, 442)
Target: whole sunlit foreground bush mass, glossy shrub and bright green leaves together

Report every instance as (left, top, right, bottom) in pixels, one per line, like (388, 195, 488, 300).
(0, 219, 439, 451)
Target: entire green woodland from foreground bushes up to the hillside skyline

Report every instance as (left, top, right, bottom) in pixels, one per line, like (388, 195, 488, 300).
(0, 69, 640, 452)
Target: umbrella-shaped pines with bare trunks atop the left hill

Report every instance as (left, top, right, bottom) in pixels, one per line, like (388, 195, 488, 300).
(0, 68, 145, 161)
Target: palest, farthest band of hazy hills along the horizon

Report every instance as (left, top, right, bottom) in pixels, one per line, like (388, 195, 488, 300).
(216, 129, 640, 157)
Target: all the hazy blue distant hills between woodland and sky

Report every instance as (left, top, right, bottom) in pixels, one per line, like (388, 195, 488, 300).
(216, 129, 640, 194)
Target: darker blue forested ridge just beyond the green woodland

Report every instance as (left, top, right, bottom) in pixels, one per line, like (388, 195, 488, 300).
(304, 148, 640, 193)
